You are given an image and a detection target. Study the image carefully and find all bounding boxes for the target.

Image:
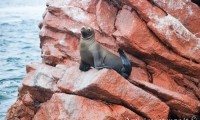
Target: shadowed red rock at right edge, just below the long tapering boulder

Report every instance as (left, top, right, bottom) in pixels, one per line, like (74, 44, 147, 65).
(147, 60, 199, 100)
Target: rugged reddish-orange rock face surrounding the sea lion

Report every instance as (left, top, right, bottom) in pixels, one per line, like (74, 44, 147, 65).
(6, 0, 200, 120)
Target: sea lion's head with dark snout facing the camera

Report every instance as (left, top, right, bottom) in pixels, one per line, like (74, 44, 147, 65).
(81, 26, 94, 39)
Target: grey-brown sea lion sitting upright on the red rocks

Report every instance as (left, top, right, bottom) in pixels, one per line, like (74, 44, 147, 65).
(79, 26, 132, 79)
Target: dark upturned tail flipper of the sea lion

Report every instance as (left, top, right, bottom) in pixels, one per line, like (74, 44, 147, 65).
(118, 48, 132, 76)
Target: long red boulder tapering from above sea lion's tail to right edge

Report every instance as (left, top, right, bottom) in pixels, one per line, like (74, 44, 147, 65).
(114, 5, 200, 78)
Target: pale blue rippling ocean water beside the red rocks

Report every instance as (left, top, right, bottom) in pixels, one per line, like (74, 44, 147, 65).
(0, 0, 46, 120)
